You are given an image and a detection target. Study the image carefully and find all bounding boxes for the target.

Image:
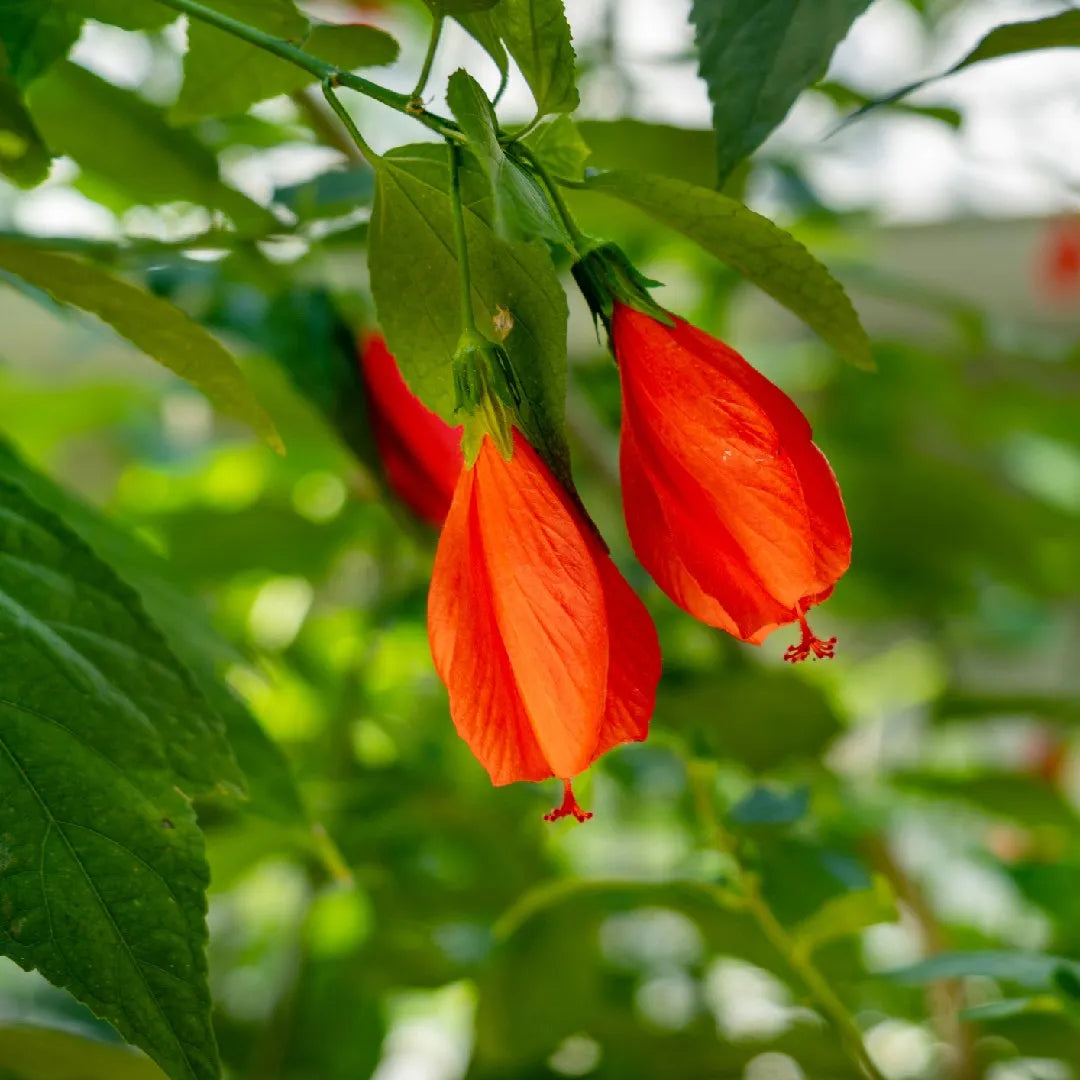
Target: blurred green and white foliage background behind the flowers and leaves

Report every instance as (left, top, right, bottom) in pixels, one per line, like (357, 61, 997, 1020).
(0, 0, 1080, 1080)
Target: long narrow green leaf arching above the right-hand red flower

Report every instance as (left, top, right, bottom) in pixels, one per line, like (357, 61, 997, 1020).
(588, 172, 873, 367)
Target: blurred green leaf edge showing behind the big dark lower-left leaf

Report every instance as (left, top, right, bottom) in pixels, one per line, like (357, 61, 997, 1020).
(0, 441, 306, 825)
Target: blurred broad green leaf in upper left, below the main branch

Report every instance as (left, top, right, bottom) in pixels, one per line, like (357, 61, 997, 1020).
(27, 63, 278, 233)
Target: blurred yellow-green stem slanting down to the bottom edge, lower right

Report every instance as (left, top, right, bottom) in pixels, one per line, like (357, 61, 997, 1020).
(688, 761, 885, 1080)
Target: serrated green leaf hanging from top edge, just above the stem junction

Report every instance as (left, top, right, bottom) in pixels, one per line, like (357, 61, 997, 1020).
(491, 0, 578, 113)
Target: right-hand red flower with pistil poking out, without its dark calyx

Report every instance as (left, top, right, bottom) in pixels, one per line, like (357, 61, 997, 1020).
(611, 300, 851, 662)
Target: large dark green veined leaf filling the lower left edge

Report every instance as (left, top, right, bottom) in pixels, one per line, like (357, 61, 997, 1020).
(0, 480, 225, 1080)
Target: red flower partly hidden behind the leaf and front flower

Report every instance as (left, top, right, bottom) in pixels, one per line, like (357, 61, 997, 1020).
(360, 334, 462, 528)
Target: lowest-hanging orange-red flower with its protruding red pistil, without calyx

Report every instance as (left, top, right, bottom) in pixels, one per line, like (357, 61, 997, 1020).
(428, 430, 660, 821)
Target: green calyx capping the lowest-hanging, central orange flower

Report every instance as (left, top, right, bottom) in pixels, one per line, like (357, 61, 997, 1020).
(454, 329, 522, 467)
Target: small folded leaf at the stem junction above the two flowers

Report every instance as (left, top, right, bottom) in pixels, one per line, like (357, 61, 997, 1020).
(446, 69, 570, 245)
